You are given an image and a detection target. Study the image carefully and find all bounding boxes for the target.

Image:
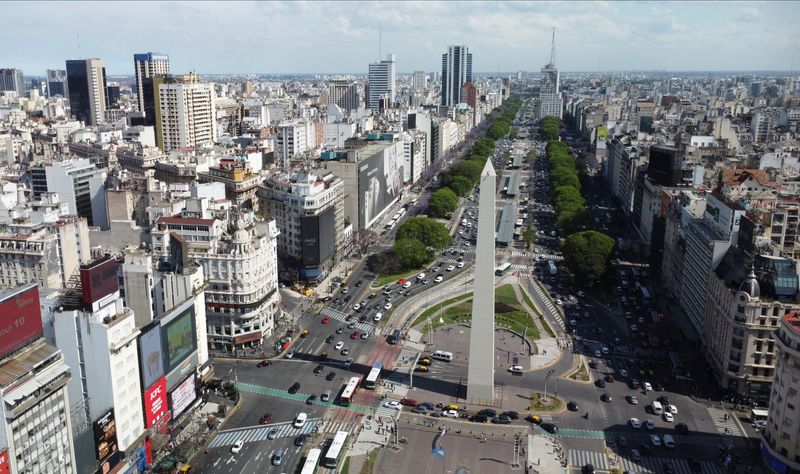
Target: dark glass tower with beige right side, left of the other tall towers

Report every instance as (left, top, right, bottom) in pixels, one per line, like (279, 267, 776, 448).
(67, 58, 107, 126)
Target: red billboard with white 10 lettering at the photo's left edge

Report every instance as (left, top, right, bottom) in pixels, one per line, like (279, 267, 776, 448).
(0, 283, 43, 357)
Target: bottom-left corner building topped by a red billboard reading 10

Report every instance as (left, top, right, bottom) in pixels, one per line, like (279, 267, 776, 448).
(0, 283, 77, 474)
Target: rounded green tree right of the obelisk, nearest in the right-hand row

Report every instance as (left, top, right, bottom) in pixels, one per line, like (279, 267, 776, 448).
(561, 230, 614, 287)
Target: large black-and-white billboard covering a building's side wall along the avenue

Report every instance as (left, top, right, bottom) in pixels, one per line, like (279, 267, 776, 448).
(358, 143, 405, 228)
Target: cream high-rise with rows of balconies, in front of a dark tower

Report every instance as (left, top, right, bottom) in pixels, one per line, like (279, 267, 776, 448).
(153, 73, 217, 152)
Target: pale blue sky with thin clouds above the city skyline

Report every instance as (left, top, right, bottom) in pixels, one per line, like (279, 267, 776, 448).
(0, 1, 800, 75)
